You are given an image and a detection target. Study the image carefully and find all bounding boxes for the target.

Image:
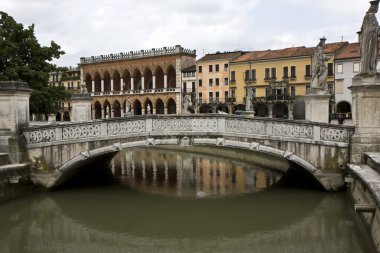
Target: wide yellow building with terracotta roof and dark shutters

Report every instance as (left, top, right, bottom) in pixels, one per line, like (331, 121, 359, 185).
(230, 42, 347, 119)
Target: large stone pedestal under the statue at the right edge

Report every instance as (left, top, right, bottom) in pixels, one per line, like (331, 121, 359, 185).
(349, 75, 380, 164)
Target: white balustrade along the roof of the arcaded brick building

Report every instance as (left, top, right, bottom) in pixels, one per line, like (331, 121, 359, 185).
(80, 45, 196, 65)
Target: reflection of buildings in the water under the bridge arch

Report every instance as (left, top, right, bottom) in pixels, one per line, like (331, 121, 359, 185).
(112, 148, 282, 197)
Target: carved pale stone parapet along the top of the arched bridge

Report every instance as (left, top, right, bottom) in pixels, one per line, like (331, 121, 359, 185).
(23, 115, 354, 147)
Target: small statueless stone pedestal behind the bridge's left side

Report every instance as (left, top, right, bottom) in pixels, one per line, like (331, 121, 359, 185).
(71, 93, 91, 122)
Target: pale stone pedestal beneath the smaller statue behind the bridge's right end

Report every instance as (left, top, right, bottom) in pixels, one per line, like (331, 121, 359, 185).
(303, 89, 331, 123)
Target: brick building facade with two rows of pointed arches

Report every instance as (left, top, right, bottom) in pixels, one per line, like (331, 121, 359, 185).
(79, 45, 196, 119)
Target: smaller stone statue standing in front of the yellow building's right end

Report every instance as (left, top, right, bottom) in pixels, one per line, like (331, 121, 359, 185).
(310, 37, 330, 92)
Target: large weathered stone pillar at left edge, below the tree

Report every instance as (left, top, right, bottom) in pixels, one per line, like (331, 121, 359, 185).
(0, 81, 32, 163)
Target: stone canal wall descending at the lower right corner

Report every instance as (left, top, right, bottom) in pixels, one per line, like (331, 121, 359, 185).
(346, 153, 380, 252)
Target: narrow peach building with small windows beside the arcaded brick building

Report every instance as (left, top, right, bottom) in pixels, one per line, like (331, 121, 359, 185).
(197, 51, 243, 113)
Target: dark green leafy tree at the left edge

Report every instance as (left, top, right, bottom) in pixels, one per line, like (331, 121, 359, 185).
(0, 11, 69, 114)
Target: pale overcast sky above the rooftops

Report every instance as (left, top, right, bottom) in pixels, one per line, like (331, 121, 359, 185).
(0, 0, 369, 66)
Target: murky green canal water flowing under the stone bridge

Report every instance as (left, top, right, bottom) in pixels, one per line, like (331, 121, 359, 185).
(0, 148, 373, 253)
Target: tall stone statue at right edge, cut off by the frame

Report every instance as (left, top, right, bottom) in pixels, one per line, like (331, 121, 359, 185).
(359, 0, 380, 76)
